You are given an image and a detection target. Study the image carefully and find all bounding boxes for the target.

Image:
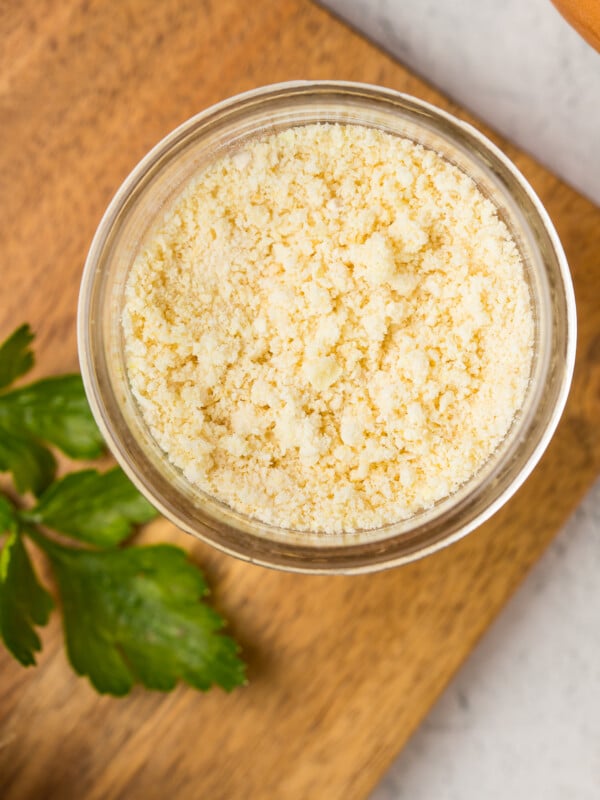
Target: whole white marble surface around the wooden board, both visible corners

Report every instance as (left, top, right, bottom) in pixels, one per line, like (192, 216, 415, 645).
(323, 0, 600, 800)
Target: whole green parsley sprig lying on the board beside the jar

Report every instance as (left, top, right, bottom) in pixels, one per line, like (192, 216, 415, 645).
(0, 325, 244, 695)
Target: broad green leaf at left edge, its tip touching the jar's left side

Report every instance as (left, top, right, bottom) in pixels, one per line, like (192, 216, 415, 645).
(0, 375, 104, 458)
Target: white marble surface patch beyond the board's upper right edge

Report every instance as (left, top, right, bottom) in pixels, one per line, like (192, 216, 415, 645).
(321, 0, 600, 206)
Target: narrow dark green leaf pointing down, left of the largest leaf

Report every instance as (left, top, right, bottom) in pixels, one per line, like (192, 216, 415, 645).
(0, 531, 54, 667)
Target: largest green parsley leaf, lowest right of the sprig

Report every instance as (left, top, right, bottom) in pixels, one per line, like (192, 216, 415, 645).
(43, 542, 244, 695)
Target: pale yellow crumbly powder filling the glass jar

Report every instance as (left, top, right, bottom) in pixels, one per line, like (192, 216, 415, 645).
(123, 125, 533, 532)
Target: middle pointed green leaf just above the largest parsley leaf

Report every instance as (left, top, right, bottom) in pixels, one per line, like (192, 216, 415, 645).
(26, 467, 157, 547)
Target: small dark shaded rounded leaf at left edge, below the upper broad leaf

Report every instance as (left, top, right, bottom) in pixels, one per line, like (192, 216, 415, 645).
(0, 425, 56, 494)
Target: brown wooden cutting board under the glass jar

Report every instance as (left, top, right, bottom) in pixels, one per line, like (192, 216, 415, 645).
(0, 0, 600, 800)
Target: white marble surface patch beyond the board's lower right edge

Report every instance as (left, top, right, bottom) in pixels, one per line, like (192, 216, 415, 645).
(371, 482, 600, 800)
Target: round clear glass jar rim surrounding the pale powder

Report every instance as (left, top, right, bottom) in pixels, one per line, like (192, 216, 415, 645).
(78, 81, 576, 573)
